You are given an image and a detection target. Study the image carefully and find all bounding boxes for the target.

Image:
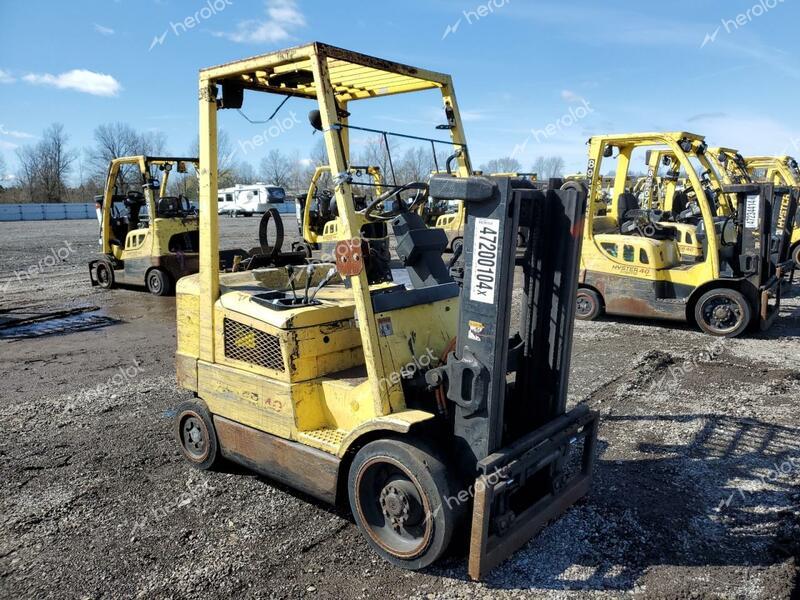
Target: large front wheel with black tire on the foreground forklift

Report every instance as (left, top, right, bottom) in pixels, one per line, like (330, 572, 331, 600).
(347, 439, 462, 570)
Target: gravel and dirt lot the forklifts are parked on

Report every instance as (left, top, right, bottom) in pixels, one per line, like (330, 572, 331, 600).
(0, 219, 800, 598)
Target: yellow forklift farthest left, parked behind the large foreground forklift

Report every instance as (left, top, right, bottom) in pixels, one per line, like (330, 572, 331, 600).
(89, 156, 199, 296)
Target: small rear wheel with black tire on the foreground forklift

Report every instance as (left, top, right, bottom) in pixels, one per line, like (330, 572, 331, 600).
(174, 400, 222, 471)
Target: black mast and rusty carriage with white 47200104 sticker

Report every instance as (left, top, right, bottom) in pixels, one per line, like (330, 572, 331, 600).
(430, 177, 598, 579)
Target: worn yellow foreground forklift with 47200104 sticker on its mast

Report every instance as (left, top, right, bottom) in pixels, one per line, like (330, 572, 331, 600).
(175, 43, 597, 579)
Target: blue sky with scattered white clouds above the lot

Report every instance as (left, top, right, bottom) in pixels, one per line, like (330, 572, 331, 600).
(0, 0, 800, 183)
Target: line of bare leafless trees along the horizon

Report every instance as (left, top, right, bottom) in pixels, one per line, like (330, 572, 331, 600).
(0, 122, 564, 203)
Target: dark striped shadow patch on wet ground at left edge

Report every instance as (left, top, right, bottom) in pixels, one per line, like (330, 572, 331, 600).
(0, 306, 122, 341)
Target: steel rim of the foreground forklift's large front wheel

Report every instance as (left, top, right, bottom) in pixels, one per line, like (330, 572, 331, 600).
(355, 456, 433, 559)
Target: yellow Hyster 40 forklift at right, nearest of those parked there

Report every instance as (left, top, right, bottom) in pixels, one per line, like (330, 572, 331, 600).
(577, 132, 788, 337)
